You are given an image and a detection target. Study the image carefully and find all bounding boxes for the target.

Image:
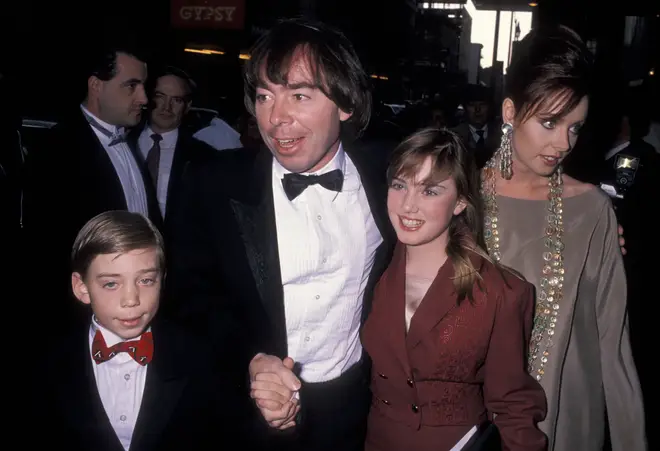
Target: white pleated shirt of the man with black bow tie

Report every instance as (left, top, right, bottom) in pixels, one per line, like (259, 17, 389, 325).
(272, 146, 383, 382)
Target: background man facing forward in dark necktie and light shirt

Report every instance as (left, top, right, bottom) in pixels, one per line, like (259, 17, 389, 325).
(130, 66, 215, 235)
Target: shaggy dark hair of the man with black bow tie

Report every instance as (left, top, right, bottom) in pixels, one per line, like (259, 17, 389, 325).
(243, 19, 371, 137)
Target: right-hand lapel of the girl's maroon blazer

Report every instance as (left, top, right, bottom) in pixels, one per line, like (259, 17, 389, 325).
(404, 258, 458, 349)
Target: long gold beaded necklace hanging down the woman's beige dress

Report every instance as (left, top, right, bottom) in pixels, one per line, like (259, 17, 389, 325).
(481, 156, 564, 381)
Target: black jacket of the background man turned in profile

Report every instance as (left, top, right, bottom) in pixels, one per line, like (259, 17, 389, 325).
(23, 109, 162, 324)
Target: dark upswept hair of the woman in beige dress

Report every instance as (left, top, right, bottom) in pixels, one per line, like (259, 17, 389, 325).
(504, 25, 593, 122)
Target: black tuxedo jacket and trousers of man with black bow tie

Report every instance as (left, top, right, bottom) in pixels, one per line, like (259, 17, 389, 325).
(161, 146, 395, 450)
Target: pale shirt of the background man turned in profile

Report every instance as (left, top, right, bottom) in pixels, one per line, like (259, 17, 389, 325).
(80, 105, 149, 218)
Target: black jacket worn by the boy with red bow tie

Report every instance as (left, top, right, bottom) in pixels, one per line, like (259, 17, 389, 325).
(26, 321, 251, 451)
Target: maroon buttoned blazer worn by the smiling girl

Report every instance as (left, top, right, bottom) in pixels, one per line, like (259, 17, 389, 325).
(362, 243, 547, 451)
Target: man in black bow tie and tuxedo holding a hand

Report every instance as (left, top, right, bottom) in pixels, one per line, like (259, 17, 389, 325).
(164, 19, 394, 451)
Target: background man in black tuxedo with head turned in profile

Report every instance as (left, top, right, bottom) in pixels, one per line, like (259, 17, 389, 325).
(23, 42, 160, 330)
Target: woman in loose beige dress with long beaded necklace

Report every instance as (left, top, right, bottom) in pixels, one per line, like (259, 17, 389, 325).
(482, 27, 646, 451)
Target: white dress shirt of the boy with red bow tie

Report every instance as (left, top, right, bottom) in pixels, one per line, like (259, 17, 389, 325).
(89, 319, 149, 451)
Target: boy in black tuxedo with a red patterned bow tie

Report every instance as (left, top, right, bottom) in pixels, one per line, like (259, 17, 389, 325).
(29, 211, 248, 451)
